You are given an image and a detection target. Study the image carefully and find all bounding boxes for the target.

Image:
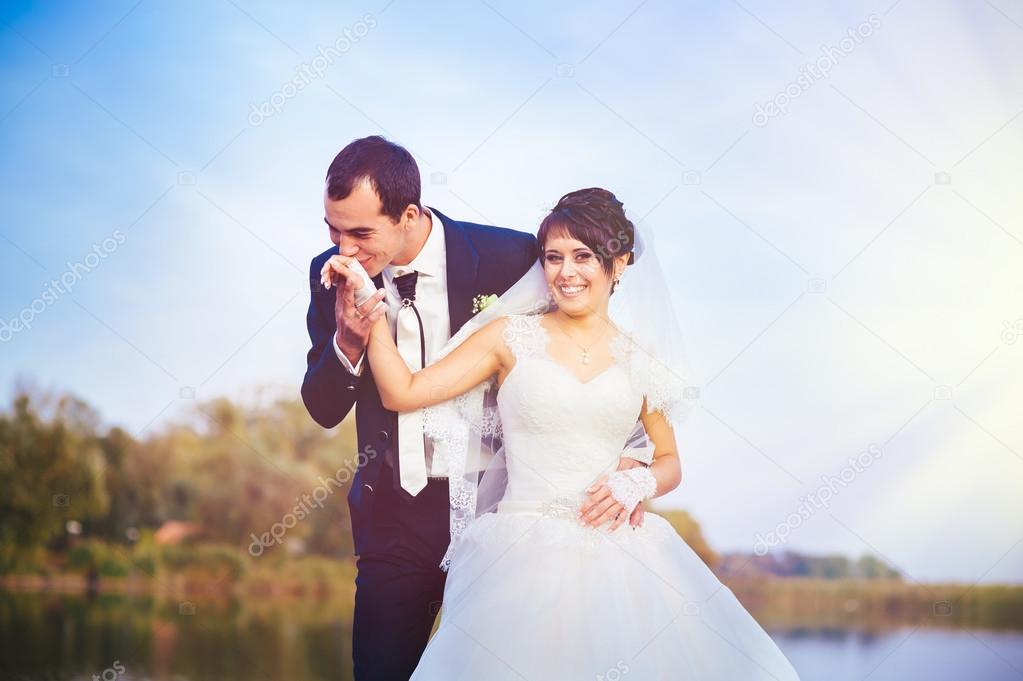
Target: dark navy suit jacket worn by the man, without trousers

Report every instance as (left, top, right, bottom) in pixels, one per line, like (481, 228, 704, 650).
(302, 208, 539, 553)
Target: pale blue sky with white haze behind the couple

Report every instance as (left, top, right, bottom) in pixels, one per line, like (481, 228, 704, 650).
(0, 0, 1023, 583)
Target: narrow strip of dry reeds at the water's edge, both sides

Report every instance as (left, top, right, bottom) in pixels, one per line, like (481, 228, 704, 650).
(0, 562, 1023, 633)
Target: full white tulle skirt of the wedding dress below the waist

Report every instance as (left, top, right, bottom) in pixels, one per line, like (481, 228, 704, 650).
(412, 512, 799, 681)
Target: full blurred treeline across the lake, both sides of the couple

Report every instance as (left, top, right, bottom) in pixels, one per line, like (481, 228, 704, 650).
(0, 390, 898, 581)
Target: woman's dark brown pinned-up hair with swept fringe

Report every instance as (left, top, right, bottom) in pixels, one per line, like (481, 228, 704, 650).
(536, 187, 636, 276)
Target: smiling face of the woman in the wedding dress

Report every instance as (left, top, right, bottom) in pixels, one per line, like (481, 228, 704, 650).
(543, 235, 627, 314)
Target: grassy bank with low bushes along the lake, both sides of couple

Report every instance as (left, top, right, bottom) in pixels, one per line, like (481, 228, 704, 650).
(0, 539, 1023, 631)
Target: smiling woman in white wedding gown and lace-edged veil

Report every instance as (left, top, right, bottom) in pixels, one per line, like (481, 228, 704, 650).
(347, 188, 798, 681)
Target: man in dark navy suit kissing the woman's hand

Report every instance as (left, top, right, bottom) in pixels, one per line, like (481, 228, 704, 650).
(302, 136, 538, 681)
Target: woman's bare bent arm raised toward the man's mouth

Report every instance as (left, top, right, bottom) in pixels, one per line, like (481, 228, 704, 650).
(368, 310, 504, 411)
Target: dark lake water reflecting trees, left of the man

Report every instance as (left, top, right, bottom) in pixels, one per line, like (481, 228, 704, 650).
(0, 592, 352, 681)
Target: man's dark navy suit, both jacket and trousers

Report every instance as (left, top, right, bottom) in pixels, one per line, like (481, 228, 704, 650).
(302, 208, 539, 681)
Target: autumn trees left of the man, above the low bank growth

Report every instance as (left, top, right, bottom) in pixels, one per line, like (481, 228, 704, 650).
(0, 390, 362, 574)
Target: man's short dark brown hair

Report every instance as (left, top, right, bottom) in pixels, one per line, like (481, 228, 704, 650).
(326, 135, 422, 221)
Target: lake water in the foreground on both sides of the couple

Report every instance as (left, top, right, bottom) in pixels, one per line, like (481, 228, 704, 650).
(0, 592, 1023, 681)
